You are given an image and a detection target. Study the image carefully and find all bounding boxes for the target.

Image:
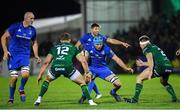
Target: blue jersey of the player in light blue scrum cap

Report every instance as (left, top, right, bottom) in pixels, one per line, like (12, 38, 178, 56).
(86, 44, 114, 68)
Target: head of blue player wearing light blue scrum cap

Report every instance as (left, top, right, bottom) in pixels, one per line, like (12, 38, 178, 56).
(93, 36, 103, 50)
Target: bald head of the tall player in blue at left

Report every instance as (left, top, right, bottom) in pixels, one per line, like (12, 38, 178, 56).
(24, 12, 35, 26)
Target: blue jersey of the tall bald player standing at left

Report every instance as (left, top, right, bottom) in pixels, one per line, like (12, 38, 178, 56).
(7, 22, 36, 55)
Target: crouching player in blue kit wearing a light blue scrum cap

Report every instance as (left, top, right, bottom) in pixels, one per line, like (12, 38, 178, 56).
(79, 36, 133, 102)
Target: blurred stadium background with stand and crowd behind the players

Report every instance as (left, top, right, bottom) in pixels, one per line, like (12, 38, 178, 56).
(0, 0, 180, 76)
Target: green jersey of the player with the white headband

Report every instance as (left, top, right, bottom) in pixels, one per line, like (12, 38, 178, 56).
(143, 44, 172, 67)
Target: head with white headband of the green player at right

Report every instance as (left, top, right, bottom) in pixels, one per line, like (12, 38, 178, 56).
(139, 35, 150, 49)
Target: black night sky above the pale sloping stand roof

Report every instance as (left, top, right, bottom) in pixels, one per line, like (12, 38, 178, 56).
(0, 0, 80, 36)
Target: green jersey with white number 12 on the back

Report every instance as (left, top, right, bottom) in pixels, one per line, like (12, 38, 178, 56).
(49, 43, 80, 69)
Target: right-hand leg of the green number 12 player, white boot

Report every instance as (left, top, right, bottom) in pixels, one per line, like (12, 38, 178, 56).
(70, 70, 97, 105)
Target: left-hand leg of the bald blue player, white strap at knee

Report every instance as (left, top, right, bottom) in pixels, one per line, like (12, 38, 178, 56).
(8, 70, 18, 104)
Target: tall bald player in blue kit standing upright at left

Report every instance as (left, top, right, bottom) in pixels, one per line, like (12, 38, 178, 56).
(1, 12, 41, 104)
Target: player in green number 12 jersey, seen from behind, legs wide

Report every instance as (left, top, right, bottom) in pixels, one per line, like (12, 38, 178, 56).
(34, 33, 97, 106)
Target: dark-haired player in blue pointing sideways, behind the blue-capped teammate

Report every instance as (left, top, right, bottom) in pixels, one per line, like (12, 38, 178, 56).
(76, 23, 130, 103)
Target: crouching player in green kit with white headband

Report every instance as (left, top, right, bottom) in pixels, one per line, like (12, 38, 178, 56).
(124, 35, 177, 103)
